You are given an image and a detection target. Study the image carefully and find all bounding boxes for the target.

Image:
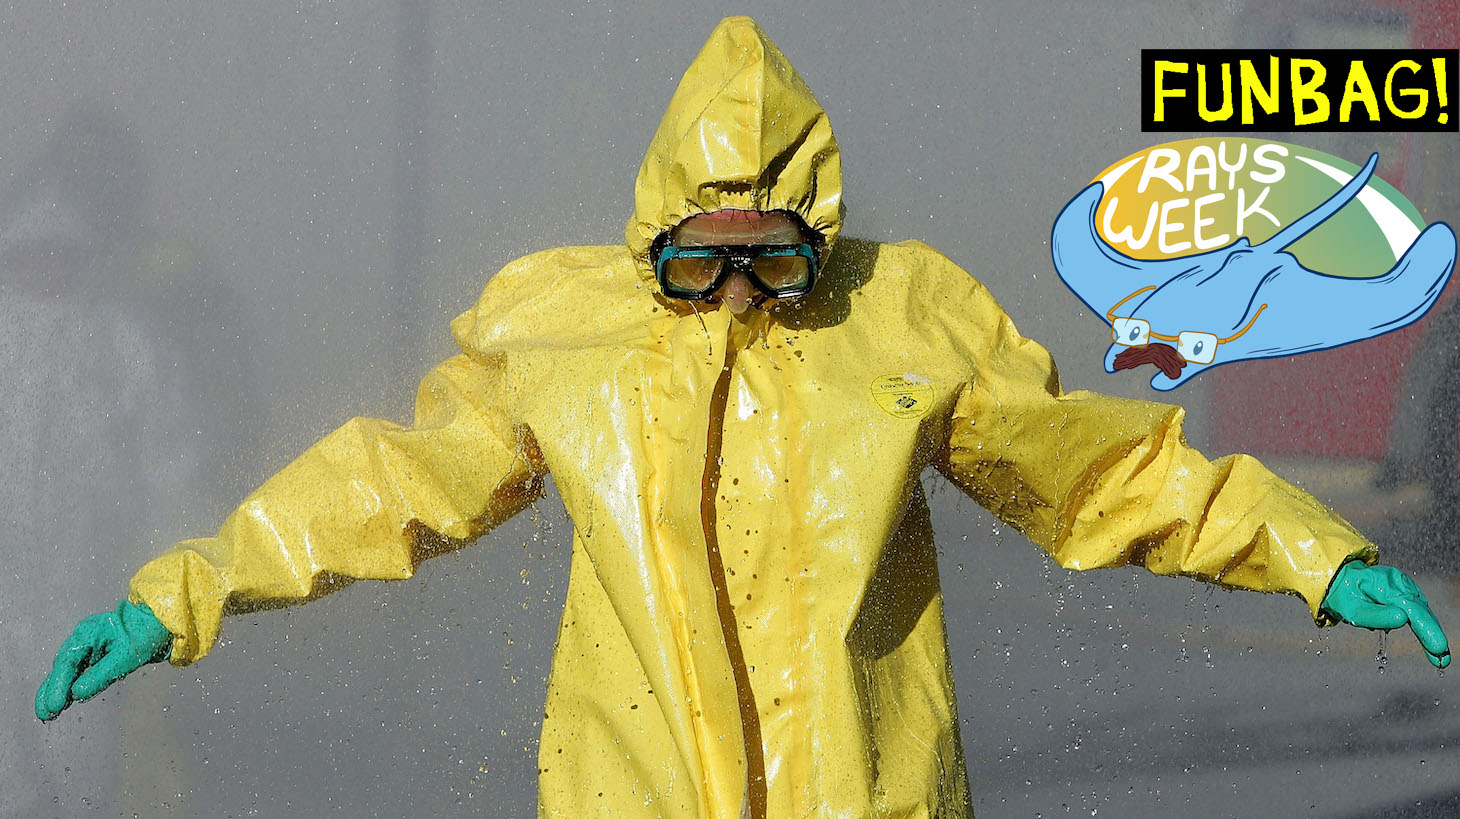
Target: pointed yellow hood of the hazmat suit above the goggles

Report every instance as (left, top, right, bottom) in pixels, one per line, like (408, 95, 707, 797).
(625, 18, 841, 269)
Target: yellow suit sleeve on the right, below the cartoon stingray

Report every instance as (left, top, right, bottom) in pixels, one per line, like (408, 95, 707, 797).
(940, 288, 1378, 625)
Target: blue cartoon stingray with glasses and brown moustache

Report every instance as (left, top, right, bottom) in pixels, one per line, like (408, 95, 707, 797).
(1050, 153, 1456, 390)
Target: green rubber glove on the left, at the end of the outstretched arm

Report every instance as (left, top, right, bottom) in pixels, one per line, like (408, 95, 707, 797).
(35, 600, 172, 721)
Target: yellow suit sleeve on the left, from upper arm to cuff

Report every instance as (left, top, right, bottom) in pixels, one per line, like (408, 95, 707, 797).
(131, 355, 545, 666)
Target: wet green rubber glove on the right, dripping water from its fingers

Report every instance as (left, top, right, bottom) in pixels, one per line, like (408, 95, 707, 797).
(1320, 561, 1450, 669)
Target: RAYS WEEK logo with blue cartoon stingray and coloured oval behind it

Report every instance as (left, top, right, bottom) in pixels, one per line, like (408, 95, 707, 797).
(1050, 137, 1456, 390)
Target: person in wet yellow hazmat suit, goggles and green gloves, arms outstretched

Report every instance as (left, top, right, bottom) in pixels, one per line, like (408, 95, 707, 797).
(37, 18, 1448, 818)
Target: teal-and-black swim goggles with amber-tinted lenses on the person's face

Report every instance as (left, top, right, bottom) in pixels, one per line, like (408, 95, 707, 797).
(654, 242, 818, 301)
